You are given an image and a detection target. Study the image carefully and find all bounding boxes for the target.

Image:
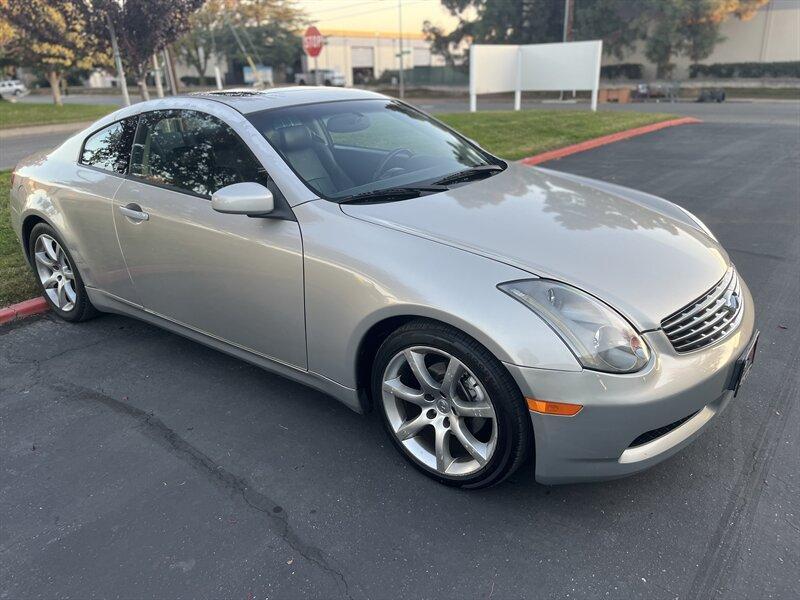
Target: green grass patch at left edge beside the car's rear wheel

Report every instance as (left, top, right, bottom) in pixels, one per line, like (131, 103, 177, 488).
(0, 171, 39, 308)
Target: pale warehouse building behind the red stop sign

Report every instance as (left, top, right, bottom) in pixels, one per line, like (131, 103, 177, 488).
(303, 30, 445, 86)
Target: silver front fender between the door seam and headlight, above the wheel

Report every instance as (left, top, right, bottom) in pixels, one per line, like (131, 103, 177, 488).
(295, 200, 581, 387)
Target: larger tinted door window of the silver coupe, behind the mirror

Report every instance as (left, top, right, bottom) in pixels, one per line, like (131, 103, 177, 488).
(131, 110, 267, 196)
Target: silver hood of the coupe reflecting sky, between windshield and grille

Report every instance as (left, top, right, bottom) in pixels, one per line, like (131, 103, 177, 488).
(342, 164, 729, 330)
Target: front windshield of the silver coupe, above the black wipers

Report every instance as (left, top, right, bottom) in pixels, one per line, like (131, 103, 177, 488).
(247, 99, 504, 201)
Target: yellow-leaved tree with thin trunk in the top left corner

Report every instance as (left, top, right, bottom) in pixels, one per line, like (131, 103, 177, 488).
(0, 0, 109, 105)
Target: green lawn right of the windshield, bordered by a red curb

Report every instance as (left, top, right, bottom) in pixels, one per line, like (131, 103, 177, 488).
(436, 110, 675, 160)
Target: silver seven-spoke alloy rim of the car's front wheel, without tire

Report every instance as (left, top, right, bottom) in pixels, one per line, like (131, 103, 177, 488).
(382, 346, 497, 476)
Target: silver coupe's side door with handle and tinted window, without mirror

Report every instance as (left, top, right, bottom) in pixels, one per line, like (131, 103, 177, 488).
(114, 110, 307, 368)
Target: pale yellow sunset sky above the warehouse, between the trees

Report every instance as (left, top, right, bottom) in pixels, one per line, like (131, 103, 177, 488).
(295, 0, 458, 33)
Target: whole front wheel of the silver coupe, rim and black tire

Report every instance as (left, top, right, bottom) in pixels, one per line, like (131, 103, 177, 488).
(372, 320, 533, 488)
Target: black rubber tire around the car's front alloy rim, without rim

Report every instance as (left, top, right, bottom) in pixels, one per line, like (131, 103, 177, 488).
(371, 319, 533, 489)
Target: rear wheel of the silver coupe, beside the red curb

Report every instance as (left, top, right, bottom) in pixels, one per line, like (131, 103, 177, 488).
(28, 223, 97, 322)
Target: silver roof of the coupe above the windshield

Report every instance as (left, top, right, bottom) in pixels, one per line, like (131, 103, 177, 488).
(190, 85, 387, 114)
